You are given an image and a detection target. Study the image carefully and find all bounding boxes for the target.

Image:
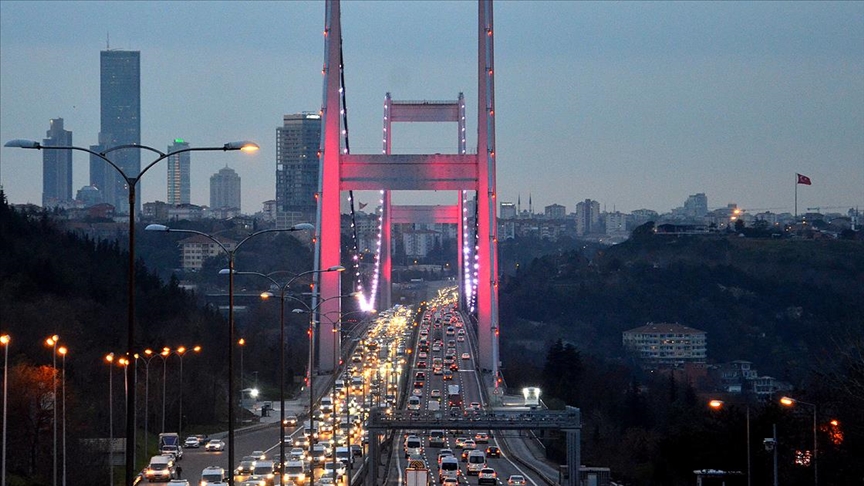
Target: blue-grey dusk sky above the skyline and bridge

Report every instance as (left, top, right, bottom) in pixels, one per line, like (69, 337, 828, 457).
(0, 0, 864, 213)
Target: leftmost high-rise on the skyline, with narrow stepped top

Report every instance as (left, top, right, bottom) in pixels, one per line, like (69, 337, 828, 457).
(42, 118, 72, 208)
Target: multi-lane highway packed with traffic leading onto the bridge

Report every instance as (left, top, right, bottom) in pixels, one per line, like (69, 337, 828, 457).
(148, 291, 554, 486)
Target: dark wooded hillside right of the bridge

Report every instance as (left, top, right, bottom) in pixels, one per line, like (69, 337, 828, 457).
(500, 227, 864, 485)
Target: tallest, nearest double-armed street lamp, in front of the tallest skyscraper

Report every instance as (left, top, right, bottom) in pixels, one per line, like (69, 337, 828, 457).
(5, 139, 259, 486)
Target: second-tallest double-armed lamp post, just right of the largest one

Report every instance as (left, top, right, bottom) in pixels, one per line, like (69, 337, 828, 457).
(144, 223, 315, 486)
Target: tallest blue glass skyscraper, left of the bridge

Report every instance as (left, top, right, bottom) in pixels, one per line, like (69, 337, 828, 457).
(90, 50, 141, 214)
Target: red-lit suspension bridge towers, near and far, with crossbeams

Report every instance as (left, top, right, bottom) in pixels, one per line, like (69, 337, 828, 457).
(315, 0, 498, 376)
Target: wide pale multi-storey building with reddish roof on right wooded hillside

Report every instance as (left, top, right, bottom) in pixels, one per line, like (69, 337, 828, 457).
(623, 322, 708, 369)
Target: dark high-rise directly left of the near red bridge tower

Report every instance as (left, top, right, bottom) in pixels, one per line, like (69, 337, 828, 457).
(276, 113, 321, 221)
